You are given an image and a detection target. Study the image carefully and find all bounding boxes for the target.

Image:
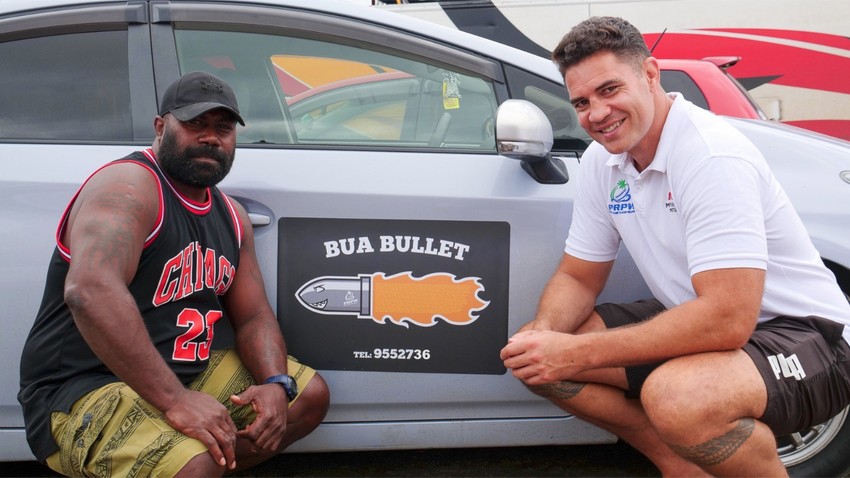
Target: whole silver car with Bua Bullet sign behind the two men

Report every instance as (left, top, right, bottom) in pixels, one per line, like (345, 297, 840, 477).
(0, 0, 850, 475)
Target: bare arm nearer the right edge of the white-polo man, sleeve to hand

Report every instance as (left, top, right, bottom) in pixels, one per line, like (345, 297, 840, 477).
(503, 269, 764, 385)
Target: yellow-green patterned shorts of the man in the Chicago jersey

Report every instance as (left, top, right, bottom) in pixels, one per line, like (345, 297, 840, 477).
(47, 349, 316, 477)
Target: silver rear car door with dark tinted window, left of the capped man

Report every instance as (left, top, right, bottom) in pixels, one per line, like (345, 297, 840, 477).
(0, 2, 156, 460)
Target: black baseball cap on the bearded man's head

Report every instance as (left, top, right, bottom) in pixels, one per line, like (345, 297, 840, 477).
(159, 71, 245, 126)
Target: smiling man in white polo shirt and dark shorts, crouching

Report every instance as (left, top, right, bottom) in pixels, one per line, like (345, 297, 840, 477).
(501, 17, 850, 476)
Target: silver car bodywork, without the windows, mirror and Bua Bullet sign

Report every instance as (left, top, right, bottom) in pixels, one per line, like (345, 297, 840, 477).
(0, 0, 850, 461)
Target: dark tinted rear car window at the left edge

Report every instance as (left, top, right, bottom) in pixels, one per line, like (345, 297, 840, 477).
(0, 31, 133, 141)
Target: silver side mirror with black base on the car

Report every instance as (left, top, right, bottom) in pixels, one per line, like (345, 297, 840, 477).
(496, 99, 569, 184)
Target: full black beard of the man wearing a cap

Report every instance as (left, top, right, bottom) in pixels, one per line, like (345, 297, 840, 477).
(156, 129, 235, 188)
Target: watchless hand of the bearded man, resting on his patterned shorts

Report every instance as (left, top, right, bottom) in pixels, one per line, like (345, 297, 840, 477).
(165, 390, 236, 470)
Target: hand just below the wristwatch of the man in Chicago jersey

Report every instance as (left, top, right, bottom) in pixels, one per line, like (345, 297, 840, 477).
(230, 383, 289, 453)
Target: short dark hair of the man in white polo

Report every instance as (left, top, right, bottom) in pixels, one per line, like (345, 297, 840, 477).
(552, 17, 649, 76)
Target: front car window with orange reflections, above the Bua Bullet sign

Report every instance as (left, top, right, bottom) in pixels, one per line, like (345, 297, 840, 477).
(175, 29, 497, 151)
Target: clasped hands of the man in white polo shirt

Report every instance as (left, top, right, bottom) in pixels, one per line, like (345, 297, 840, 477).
(499, 329, 583, 385)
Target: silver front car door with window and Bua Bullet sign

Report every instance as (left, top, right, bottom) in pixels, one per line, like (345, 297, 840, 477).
(152, 2, 608, 450)
